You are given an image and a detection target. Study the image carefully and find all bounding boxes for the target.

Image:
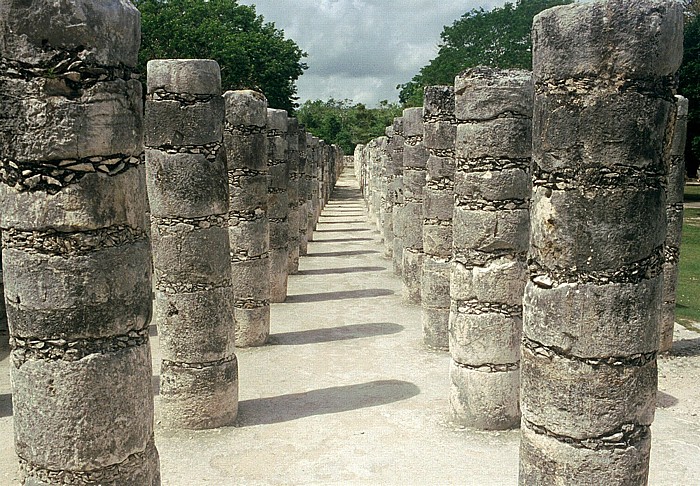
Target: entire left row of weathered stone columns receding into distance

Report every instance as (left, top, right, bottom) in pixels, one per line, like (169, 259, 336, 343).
(0, 0, 343, 478)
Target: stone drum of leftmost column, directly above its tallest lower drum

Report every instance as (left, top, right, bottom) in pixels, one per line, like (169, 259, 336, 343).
(3, 239, 151, 339)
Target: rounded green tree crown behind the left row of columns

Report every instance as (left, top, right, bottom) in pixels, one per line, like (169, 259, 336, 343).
(134, 0, 306, 113)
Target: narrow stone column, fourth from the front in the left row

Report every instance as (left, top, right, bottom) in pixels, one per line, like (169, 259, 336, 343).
(267, 108, 289, 302)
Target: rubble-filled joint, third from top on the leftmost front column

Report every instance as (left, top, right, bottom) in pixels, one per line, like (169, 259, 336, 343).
(2, 225, 148, 257)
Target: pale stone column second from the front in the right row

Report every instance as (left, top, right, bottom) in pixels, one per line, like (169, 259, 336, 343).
(449, 67, 533, 430)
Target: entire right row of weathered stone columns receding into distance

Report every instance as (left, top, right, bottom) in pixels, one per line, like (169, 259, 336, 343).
(355, 0, 687, 484)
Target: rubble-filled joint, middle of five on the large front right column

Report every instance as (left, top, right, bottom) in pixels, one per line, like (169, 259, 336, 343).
(527, 245, 664, 289)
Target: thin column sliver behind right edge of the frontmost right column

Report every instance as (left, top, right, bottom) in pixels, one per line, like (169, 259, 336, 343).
(659, 96, 688, 353)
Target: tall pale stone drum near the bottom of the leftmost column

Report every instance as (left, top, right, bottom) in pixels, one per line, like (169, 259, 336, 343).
(10, 344, 153, 471)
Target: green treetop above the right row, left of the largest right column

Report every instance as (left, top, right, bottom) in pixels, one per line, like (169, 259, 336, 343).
(397, 0, 572, 106)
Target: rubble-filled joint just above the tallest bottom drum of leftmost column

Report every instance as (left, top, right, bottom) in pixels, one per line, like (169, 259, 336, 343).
(10, 328, 148, 369)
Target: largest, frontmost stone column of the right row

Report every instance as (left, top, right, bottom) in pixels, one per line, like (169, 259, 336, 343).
(520, 0, 683, 485)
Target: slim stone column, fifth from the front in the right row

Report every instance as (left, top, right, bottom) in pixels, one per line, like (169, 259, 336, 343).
(389, 117, 405, 275)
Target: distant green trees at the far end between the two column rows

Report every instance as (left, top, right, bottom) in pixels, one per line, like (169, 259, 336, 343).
(297, 98, 402, 155)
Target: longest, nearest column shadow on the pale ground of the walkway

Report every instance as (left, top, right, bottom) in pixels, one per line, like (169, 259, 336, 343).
(237, 380, 420, 427)
